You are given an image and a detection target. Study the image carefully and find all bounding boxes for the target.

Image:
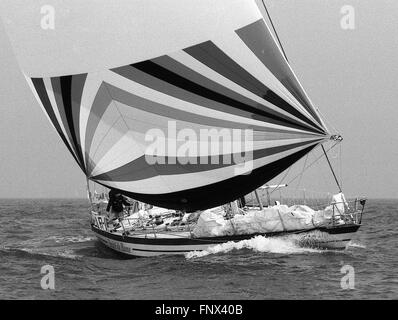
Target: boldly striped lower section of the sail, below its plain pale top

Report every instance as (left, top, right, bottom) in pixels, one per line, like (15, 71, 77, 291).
(26, 19, 329, 210)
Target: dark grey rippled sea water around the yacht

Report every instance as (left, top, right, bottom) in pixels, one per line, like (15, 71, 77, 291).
(0, 199, 398, 299)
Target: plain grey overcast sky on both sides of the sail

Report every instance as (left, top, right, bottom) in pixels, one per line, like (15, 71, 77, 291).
(0, 0, 398, 198)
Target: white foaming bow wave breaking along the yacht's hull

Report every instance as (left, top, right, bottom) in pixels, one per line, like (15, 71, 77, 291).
(185, 235, 324, 259)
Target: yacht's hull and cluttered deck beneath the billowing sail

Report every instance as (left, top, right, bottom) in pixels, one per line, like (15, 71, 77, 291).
(91, 186, 366, 257)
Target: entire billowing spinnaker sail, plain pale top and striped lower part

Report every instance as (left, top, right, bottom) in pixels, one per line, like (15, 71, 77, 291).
(0, 0, 330, 211)
